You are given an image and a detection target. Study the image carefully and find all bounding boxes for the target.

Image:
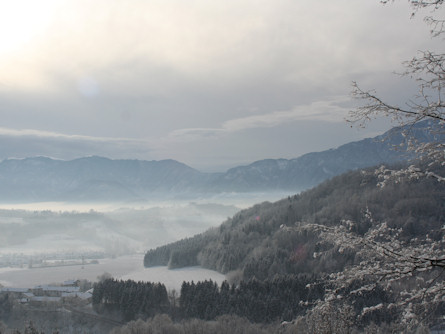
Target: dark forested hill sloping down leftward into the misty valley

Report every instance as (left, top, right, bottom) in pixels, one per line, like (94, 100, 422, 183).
(144, 164, 445, 279)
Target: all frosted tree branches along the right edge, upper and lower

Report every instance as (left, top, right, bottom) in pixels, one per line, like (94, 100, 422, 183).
(296, 0, 445, 331)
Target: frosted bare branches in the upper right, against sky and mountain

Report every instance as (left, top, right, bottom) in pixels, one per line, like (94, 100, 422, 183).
(348, 0, 445, 185)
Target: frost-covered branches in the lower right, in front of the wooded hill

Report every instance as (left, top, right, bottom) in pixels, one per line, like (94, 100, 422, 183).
(300, 206, 445, 330)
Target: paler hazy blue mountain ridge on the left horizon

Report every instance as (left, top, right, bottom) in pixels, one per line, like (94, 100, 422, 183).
(0, 156, 210, 201)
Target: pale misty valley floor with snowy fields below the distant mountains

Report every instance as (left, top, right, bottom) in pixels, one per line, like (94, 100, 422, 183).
(0, 193, 288, 289)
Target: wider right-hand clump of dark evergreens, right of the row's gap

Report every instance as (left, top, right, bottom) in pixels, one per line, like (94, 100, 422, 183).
(179, 275, 324, 323)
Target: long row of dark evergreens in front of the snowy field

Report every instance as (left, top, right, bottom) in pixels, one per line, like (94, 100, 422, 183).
(93, 275, 390, 323)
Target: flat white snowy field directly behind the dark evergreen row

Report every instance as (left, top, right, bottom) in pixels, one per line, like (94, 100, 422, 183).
(0, 254, 225, 291)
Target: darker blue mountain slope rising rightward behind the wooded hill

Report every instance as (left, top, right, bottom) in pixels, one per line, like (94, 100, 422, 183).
(207, 121, 438, 191)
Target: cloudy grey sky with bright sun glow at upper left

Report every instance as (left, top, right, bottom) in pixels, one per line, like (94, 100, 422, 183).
(0, 0, 440, 171)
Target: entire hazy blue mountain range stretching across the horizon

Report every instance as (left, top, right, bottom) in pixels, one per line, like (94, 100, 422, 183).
(0, 122, 434, 202)
